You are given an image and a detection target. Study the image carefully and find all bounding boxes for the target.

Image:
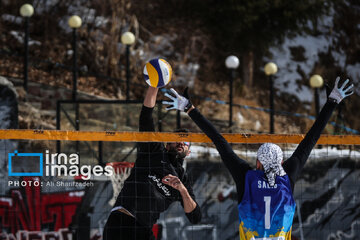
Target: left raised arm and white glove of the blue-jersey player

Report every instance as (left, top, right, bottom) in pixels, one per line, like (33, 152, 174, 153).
(163, 88, 250, 184)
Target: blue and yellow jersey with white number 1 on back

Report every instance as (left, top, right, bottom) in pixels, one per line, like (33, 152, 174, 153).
(238, 170, 296, 240)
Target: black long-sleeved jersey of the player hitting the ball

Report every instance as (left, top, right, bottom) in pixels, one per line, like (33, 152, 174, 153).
(114, 106, 201, 228)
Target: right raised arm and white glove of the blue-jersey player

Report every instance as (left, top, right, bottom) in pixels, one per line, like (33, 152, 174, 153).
(283, 77, 354, 183)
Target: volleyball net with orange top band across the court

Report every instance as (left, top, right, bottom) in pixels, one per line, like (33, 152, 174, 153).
(0, 130, 360, 239)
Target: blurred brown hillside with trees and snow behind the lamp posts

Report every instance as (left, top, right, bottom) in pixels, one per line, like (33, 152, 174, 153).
(0, 0, 360, 133)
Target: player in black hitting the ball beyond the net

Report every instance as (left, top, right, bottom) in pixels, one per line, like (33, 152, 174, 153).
(103, 87, 201, 240)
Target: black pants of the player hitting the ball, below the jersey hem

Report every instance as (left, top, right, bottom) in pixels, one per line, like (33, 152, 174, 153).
(103, 211, 155, 240)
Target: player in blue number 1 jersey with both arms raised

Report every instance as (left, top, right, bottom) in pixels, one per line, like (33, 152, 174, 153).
(163, 77, 353, 240)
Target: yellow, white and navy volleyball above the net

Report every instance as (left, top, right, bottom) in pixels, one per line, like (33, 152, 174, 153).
(143, 58, 172, 88)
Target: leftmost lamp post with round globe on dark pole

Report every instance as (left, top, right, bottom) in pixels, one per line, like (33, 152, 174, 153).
(20, 3, 34, 92)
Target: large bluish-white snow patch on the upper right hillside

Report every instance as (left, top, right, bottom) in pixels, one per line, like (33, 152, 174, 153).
(264, 6, 360, 105)
